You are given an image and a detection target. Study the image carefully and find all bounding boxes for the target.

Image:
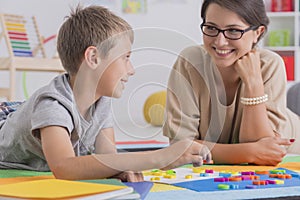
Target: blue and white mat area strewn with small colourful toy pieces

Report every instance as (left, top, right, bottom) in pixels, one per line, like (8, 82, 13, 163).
(144, 167, 300, 192)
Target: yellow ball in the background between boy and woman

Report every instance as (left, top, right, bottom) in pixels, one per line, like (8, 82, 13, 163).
(144, 91, 167, 126)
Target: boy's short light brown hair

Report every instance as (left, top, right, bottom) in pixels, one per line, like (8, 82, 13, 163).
(57, 6, 133, 75)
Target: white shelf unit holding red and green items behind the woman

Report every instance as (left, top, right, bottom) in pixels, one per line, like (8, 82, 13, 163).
(262, 0, 300, 84)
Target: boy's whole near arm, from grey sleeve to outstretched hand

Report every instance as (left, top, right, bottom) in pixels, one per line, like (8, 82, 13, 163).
(41, 126, 210, 180)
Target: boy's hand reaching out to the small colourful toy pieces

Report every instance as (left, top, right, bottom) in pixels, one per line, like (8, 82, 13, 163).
(163, 139, 212, 170)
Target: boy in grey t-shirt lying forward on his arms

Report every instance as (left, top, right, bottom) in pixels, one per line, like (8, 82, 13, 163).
(0, 6, 210, 181)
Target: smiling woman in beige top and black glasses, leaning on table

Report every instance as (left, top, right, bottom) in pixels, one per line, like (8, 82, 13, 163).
(164, 0, 300, 165)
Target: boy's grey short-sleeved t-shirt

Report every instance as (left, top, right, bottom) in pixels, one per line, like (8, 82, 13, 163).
(0, 74, 113, 171)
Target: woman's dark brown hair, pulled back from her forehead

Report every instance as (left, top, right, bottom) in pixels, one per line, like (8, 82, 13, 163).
(201, 0, 270, 40)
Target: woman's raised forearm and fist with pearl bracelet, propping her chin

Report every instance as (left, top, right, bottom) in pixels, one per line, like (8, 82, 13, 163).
(236, 57, 274, 143)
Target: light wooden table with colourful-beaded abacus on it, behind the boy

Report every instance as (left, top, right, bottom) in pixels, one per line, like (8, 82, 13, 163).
(0, 14, 64, 101)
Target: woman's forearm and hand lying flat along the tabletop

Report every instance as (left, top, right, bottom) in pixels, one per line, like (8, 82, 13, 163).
(198, 137, 291, 165)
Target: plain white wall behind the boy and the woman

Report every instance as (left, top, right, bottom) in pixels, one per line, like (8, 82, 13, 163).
(0, 0, 202, 141)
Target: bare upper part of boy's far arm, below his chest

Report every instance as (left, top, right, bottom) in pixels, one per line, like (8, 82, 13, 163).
(95, 128, 117, 154)
